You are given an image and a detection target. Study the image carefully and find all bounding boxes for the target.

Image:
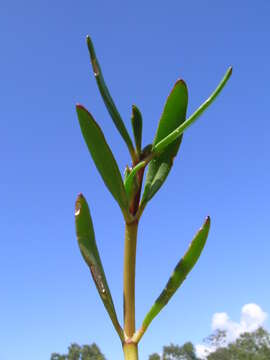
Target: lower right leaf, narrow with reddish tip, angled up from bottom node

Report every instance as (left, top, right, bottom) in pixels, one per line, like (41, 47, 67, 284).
(138, 217, 210, 338)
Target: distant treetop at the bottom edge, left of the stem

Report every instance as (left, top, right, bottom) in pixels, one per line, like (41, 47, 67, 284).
(50, 343, 106, 360)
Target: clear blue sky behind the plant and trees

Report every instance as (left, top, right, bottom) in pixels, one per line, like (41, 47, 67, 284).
(0, 0, 270, 360)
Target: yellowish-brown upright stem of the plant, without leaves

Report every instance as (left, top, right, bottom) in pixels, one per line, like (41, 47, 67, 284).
(123, 221, 138, 360)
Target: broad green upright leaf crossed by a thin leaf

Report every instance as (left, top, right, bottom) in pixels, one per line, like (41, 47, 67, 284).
(142, 80, 188, 204)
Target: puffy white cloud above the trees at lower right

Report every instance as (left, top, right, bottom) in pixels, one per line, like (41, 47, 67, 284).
(196, 303, 268, 359)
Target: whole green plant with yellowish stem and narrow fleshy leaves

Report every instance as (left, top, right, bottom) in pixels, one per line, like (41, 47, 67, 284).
(75, 36, 232, 360)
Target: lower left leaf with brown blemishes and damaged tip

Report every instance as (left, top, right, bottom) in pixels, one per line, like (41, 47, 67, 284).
(75, 194, 123, 340)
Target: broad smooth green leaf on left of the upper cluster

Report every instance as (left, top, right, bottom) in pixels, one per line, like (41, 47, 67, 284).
(76, 105, 129, 220)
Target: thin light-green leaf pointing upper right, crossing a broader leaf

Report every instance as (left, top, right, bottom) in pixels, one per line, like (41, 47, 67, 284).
(152, 67, 232, 154)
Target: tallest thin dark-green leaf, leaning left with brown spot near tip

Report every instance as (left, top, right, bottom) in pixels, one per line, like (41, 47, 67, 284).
(86, 35, 135, 159)
